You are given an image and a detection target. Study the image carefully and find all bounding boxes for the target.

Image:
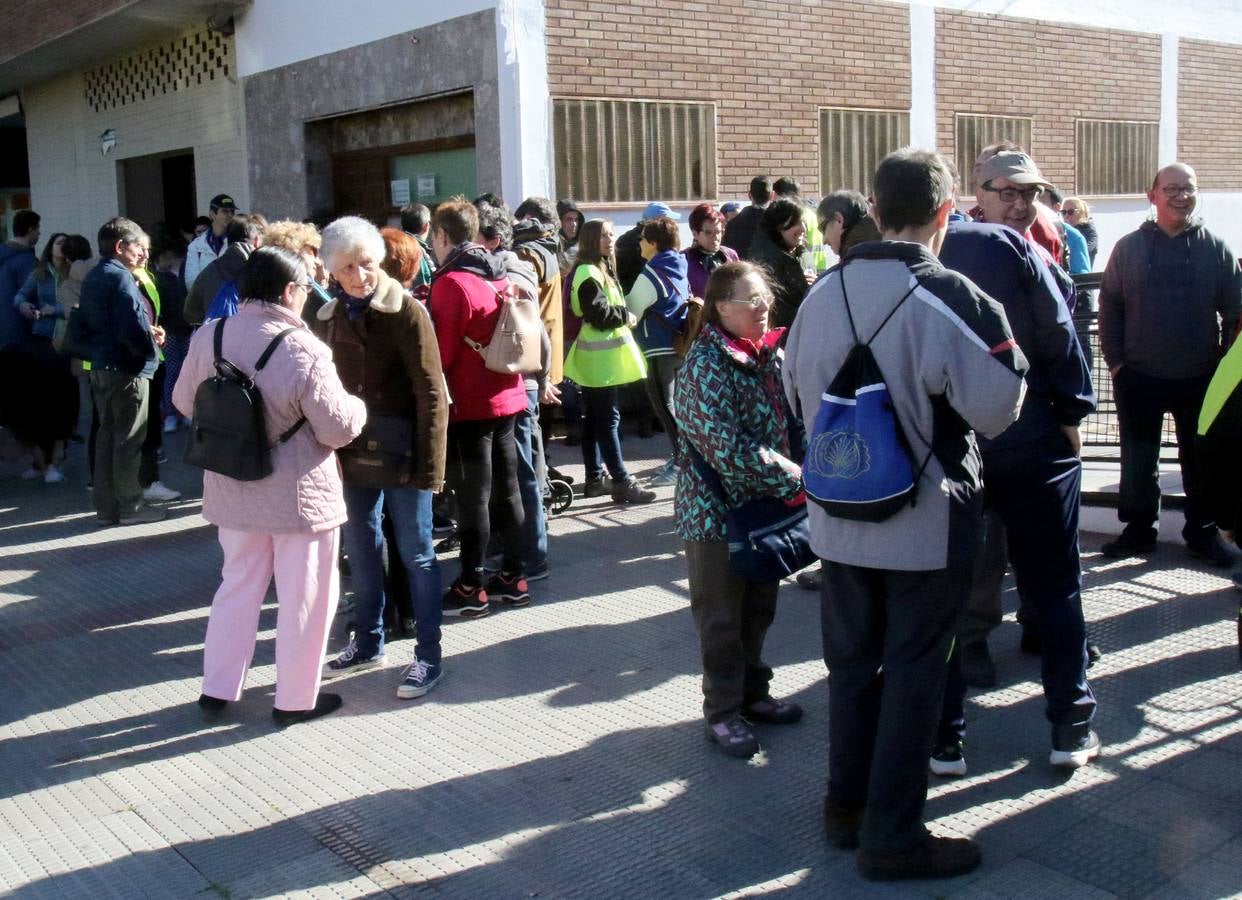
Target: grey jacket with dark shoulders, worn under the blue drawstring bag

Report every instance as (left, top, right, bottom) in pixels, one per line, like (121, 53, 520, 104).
(784, 241, 1027, 571)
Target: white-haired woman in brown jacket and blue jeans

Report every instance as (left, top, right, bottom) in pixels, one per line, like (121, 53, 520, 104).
(314, 216, 448, 699)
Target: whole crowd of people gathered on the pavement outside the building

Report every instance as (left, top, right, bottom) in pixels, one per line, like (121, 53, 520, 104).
(0, 142, 1242, 879)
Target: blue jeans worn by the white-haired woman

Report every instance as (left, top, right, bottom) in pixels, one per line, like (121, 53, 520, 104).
(340, 484, 443, 665)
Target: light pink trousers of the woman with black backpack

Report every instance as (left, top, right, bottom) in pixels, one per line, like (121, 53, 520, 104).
(202, 528, 340, 711)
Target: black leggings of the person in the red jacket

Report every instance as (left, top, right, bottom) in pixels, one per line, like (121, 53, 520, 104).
(447, 416, 524, 587)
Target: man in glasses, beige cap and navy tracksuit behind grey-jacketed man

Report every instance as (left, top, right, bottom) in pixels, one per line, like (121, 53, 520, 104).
(930, 153, 1099, 776)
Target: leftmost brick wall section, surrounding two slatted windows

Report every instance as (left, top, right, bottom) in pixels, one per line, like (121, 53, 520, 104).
(546, 0, 910, 197)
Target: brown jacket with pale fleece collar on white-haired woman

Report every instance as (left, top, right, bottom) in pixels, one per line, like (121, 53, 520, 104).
(313, 272, 448, 490)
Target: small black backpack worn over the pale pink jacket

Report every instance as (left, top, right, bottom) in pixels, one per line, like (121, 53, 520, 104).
(185, 319, 307, 482)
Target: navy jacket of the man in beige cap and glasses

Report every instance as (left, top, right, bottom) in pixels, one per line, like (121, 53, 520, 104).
(940, 221, 1095, 454)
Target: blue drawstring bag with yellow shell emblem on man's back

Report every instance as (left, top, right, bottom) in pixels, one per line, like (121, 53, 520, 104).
(802, 266, 932, 521)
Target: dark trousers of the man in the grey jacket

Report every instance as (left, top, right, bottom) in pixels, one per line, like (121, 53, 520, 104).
(820, 561, 970, 853)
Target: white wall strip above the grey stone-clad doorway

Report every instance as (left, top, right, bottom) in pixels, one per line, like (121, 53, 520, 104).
(236, 0, 497, 77)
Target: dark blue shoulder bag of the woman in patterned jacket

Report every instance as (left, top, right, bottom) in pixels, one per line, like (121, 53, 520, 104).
(689, 447, 816, 583)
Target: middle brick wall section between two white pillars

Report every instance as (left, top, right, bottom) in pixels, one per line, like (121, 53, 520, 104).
(935, 10, 1160, 192)
